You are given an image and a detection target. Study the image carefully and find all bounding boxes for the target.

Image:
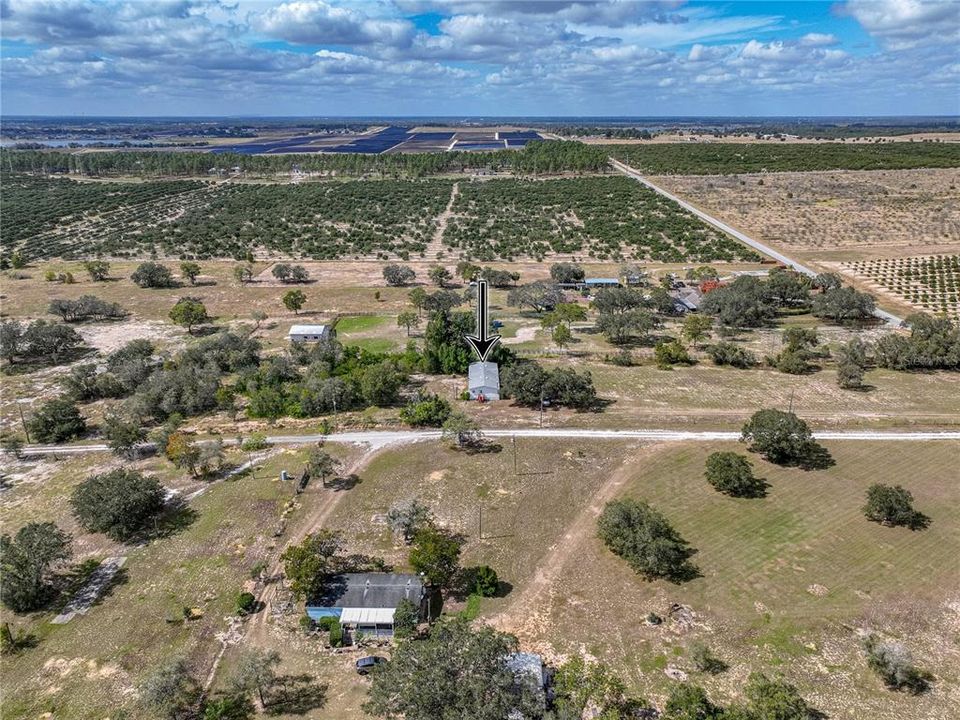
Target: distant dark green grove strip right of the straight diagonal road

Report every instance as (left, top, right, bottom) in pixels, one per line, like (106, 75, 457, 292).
(606, 142, 960, 175)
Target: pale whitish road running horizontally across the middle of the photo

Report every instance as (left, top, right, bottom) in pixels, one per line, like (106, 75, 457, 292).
(23, 428, 960, 455)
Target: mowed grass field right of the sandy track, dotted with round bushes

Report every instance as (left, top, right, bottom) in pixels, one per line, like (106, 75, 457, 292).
(492, 443, 960, 720)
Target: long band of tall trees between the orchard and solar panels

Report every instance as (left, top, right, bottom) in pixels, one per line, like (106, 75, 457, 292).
(0, 141, 607, 177)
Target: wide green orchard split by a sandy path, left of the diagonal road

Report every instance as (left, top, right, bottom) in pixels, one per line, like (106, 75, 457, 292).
(8, 176, 759, 263)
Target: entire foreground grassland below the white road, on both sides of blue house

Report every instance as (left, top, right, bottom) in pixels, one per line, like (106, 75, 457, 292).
(0, 430, 960, 720)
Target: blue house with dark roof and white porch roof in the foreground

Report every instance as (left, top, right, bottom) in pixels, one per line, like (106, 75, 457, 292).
(306, 573, 429, 637)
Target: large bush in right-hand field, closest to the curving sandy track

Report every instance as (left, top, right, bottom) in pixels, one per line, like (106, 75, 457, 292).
(598, 500, 696, 581)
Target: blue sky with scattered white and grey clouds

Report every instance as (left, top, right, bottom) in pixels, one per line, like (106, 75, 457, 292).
(0, 0, 960, 117)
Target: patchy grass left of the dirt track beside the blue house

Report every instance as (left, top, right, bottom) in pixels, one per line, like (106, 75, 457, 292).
(0, 449, 362, 720)
